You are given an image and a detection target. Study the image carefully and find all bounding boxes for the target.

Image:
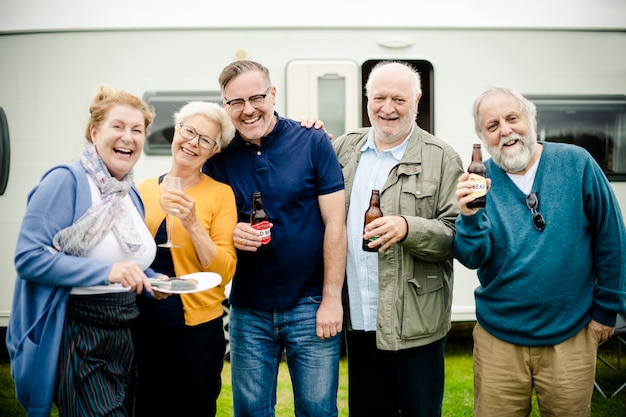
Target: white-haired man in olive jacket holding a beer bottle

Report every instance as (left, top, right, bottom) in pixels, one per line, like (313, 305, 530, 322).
(333, 62, 463, 417)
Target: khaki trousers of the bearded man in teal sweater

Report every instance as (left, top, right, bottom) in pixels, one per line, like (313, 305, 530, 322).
(473, 323, 598, 417)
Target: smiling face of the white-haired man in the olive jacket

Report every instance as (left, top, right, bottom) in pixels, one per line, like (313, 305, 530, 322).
(367, 64, 421, 149)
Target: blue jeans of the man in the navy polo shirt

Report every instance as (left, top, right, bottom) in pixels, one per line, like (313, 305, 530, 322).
(229, 297, 341, 417)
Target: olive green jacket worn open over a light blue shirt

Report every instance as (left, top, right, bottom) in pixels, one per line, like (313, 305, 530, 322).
(333, 125, 463, 351)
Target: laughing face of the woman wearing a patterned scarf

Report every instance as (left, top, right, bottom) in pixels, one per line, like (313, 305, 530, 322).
(89, 105, 146, 180)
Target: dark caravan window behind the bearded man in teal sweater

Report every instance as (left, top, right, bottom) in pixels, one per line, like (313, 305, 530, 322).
(527, 95, 626, 181)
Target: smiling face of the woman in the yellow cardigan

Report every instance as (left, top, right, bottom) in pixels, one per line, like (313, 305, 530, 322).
(172, 114, 221, 172)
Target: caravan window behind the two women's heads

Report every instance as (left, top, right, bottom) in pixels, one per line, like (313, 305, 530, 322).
(143, 91, 222, 155)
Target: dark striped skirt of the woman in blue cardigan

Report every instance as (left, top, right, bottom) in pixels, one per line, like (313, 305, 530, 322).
(54, 291, 139, 417)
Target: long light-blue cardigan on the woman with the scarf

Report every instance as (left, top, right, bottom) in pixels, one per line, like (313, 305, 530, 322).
(6, 162, 154, 417)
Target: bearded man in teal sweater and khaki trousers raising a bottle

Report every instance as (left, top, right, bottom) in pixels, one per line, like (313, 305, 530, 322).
(454, 88, 626, 417)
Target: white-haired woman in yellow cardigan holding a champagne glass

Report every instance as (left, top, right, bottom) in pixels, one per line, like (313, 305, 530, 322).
(135, 102, 237, 417)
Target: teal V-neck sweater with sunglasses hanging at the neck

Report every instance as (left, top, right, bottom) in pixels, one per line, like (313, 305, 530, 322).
(454, 143, 626, 346)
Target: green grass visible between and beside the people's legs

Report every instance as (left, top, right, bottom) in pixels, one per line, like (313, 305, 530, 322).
(0, 323, 626, 417)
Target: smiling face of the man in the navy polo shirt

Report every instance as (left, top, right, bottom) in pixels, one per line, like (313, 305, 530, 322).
(223, 70, 276, 144)
